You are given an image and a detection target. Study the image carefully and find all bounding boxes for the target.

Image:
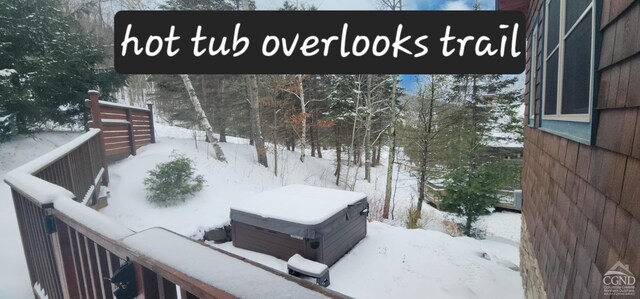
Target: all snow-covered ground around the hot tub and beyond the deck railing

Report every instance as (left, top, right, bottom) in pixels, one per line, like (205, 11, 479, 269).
(0, 125, 523, 298)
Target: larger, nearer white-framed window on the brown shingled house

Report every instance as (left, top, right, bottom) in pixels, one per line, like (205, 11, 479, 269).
(542, 0, 596, 123)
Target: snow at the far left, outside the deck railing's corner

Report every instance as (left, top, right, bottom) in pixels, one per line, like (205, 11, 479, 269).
(0, 132, 81, 298)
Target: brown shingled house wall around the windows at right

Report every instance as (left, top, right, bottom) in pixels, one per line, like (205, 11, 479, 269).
(521, 0, 640, 298)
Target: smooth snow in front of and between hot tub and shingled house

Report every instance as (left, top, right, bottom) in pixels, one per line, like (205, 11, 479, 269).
(208, 221, 524, 299)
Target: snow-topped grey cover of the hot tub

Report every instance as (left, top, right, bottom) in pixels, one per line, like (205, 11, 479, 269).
(230, 185, 367, 239)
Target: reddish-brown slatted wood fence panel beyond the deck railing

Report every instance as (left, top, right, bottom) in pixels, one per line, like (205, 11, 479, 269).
(86, 91, 156, 161)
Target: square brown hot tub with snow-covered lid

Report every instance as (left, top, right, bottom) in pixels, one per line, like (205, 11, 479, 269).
(230, 185, 369, 266)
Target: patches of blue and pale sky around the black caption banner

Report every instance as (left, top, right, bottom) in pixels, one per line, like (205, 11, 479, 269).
(255, 0, 502, 93)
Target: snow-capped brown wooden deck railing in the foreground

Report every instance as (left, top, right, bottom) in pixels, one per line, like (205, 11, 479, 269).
(5, 129, 345, 299)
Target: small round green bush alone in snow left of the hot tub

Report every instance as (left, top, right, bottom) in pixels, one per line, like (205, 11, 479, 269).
(144, 152, 205, 206)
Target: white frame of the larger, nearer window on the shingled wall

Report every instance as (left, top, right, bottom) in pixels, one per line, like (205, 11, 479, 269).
(540, 0, 596, 123)
